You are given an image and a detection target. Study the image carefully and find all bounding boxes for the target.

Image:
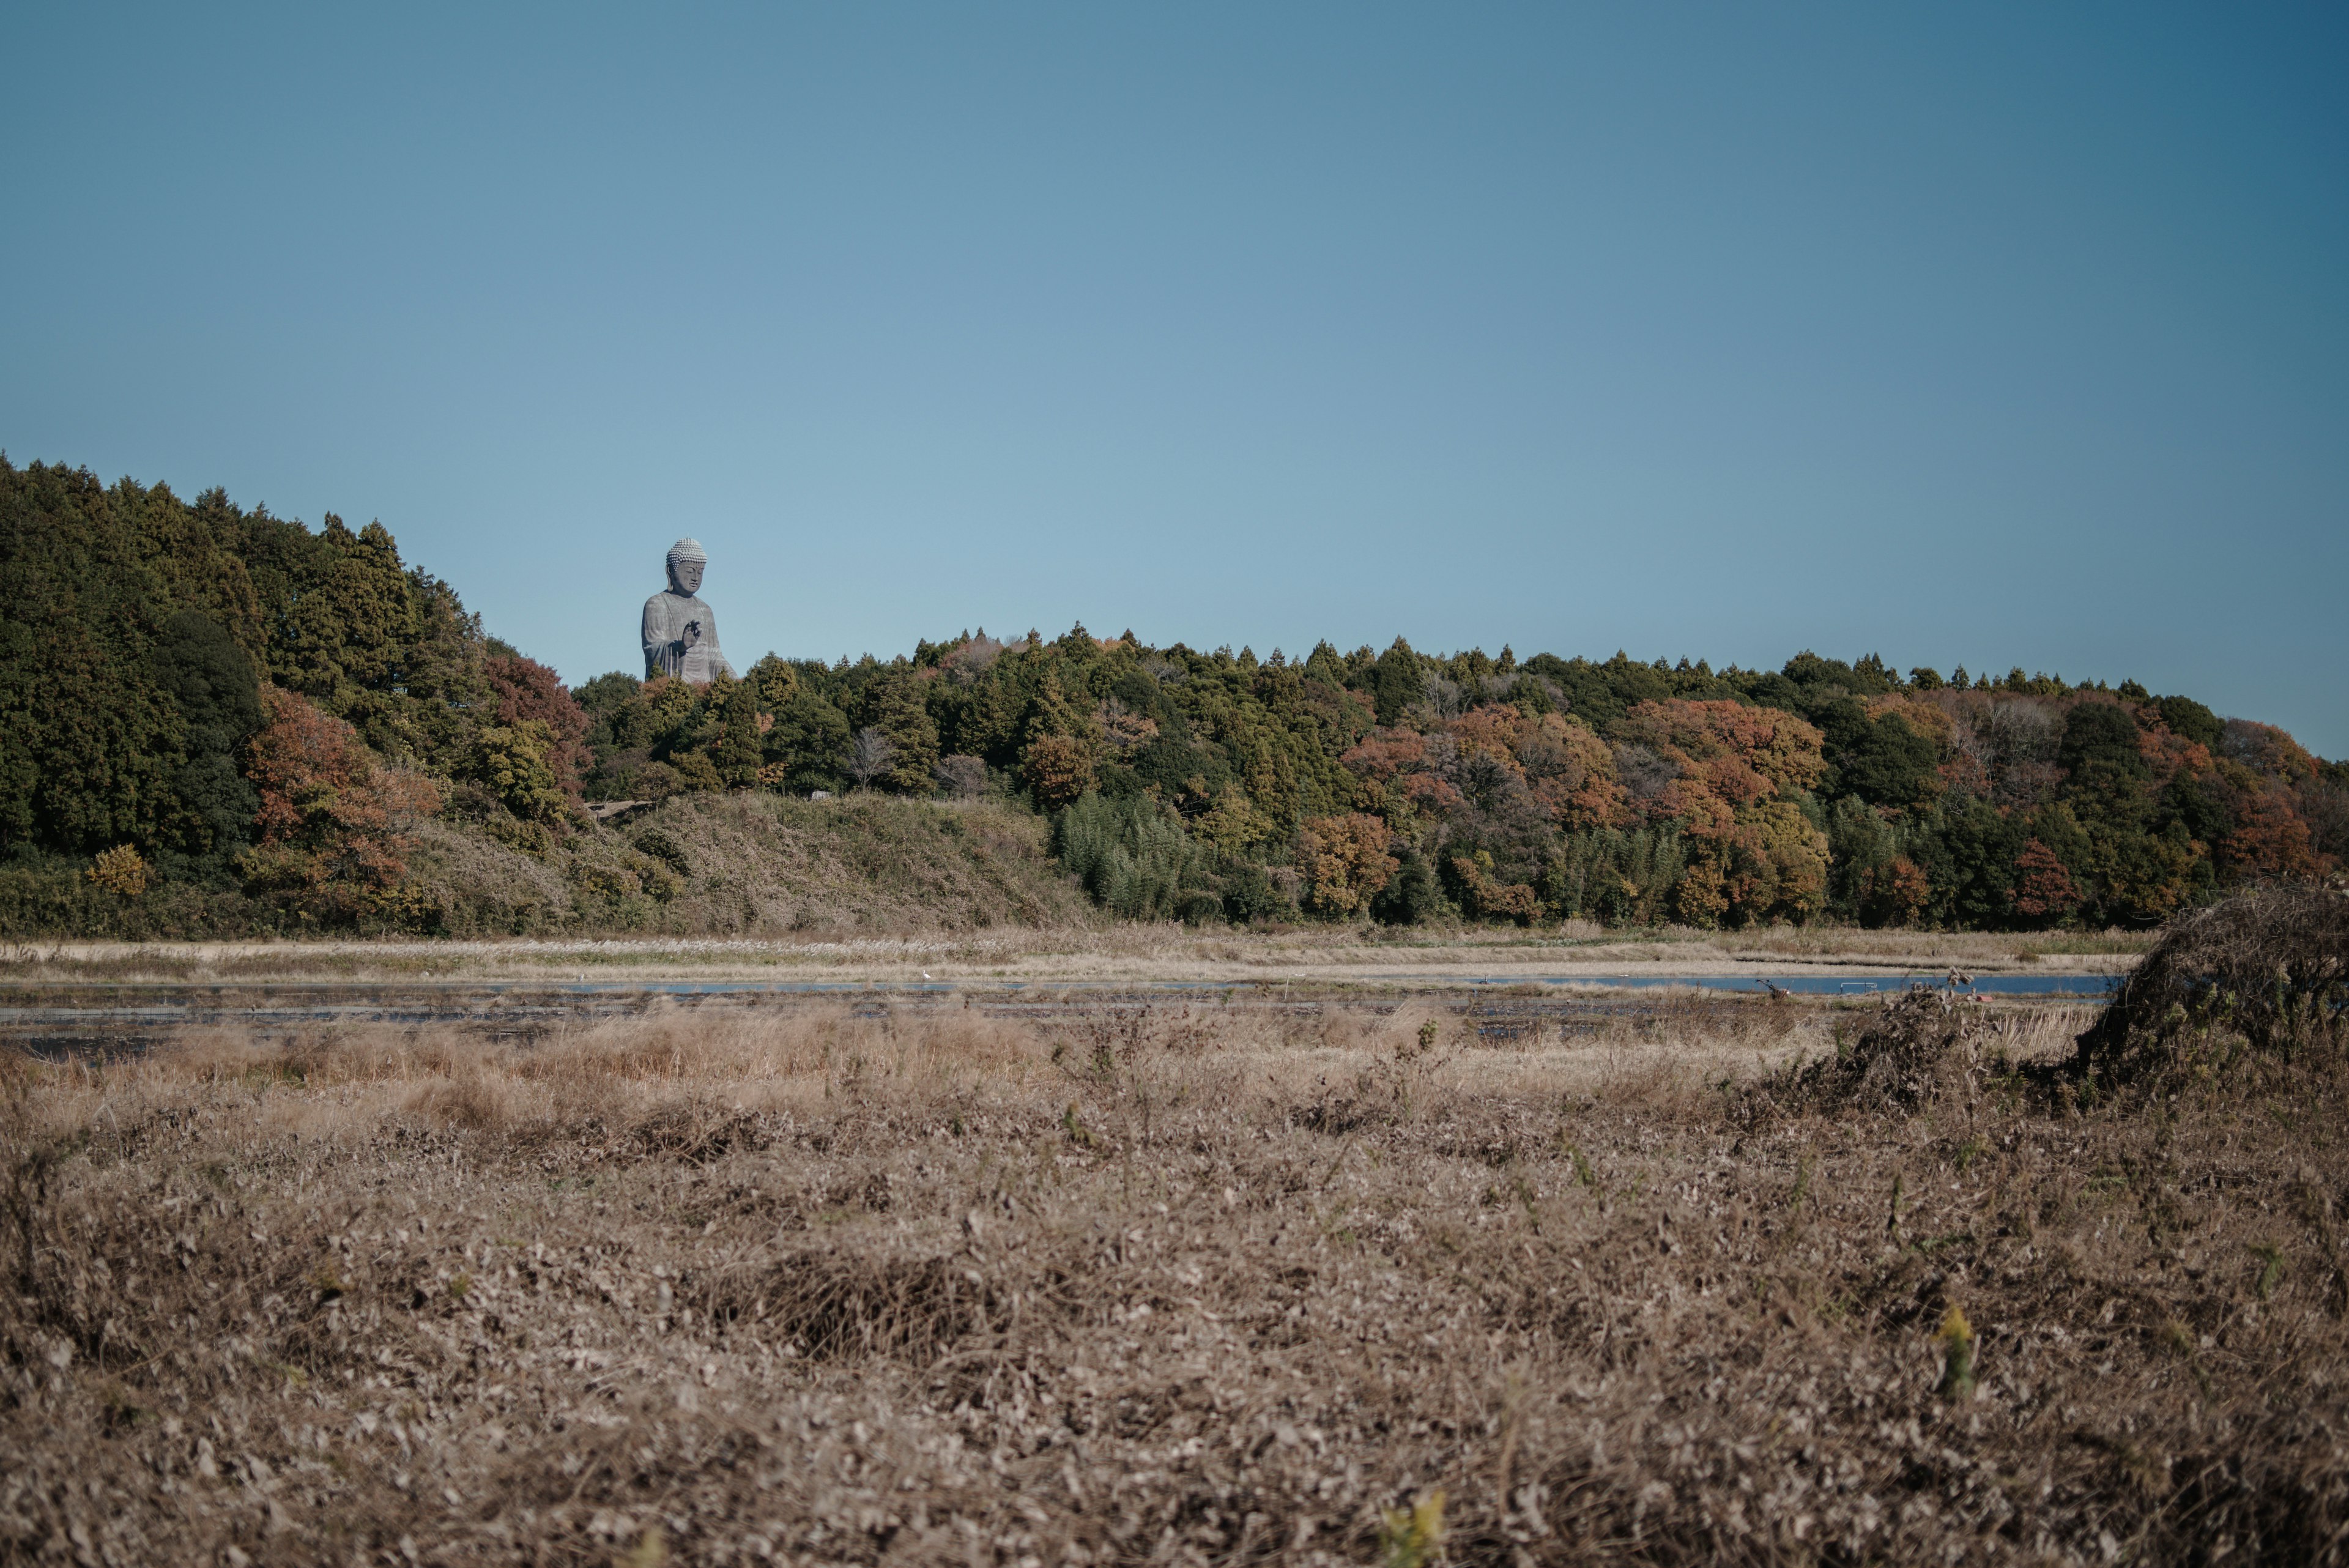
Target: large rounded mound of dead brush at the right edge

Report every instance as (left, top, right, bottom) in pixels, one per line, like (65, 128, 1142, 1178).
(2072, 886, 2349, 1088)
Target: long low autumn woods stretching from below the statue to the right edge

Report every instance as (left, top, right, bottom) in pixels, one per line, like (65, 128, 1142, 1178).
(580, 628, 2349, 926)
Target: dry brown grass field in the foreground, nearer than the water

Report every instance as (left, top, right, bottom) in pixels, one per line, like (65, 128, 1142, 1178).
(0, 959, 2349, 1568)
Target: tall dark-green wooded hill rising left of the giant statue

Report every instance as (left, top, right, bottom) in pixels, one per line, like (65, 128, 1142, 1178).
(0, 456, 585, 931)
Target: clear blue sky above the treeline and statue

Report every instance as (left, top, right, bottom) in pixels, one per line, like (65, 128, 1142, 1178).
(0, 5, 2349, 757)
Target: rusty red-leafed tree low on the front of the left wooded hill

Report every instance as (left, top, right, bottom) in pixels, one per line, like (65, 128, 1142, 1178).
(242, 686, 439, 919)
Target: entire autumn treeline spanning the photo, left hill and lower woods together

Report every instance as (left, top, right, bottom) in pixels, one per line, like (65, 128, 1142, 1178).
(0, 458, 2349, 929)
